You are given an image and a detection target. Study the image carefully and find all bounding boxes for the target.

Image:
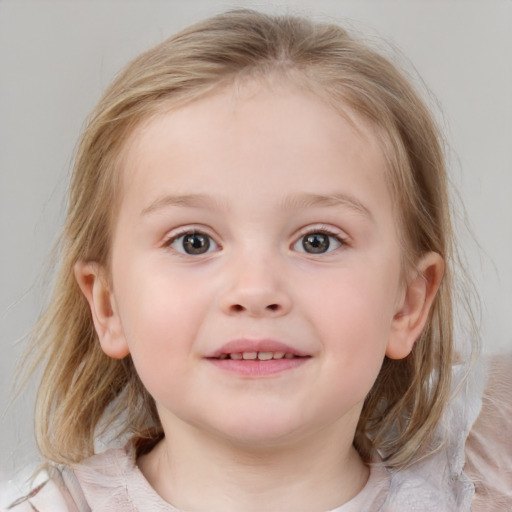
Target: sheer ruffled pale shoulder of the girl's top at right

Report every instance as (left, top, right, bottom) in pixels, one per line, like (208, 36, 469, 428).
(404, 352, 512, 512)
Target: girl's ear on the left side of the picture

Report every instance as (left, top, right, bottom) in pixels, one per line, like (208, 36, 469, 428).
(74, 261, 130, 359)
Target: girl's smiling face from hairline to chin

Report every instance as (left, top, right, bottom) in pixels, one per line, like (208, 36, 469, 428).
(91, 82, 420, 444)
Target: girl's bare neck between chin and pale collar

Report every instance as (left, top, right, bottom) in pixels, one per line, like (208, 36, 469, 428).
(138, 420, 368, 512)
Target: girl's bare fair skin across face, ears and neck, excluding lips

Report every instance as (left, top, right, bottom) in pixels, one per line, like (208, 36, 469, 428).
(76, 83, 443, 511)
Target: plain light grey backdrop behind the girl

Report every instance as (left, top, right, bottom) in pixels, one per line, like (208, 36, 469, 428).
(0, 0, 512, 477)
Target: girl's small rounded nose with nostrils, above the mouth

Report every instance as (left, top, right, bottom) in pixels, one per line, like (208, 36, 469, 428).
(221, 254, 292, 317)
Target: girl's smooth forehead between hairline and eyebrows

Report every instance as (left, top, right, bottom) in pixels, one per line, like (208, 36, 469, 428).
(117, 82, 390, 223)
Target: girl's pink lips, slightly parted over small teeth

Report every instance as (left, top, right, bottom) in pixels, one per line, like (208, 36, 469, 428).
(206, 339, 311, 377)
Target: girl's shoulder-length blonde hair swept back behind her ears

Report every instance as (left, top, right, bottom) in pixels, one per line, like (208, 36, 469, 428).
(30, 10, 453, 467)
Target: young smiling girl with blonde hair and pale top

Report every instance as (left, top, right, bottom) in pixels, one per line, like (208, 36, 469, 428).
(2, 11, 510, 512)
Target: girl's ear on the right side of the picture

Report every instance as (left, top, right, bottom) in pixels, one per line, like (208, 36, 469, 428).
(386, 252, 444, 359)
